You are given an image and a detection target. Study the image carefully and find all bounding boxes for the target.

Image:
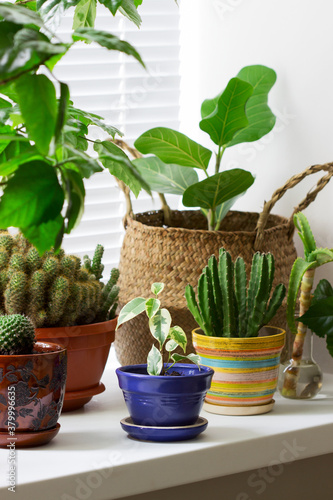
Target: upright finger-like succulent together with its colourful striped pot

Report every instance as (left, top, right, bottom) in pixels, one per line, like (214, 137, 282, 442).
(185, 249, 286, 415)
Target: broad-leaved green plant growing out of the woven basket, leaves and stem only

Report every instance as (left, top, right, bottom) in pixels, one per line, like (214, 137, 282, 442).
(133, 65, 276, 230)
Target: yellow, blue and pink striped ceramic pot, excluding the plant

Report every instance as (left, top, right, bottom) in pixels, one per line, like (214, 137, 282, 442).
(192, 326, 285, 415)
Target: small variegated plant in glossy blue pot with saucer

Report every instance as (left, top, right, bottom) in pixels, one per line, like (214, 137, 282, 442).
(116, 283, 213, 441)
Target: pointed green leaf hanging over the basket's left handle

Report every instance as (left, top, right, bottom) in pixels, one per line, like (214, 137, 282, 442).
(94, 141, 150, 197)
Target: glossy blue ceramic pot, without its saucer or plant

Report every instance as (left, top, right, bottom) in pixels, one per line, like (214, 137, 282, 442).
(116, 363, 214, 427)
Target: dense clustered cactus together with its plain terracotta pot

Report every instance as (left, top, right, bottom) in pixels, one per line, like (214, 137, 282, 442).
(0, 232, 119, 411)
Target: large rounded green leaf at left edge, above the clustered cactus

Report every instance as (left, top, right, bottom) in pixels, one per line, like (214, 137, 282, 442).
(0, 160, 64, 228)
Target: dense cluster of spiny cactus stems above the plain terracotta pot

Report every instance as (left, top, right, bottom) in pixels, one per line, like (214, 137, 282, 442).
(0, 231, 119, 328)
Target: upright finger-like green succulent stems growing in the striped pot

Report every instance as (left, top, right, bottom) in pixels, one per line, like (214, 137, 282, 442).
(185, 248, 286, 337)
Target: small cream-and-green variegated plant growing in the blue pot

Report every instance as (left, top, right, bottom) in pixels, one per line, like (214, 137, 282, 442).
(116, 283, 200, 375)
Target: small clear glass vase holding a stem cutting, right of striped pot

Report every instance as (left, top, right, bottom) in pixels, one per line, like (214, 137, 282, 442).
(278, 329, 323, 399)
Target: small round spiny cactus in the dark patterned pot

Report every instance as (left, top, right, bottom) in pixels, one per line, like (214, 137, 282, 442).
(0, 314, 35, 355)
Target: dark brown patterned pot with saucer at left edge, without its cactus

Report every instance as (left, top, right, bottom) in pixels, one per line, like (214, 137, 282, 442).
(0, 342, 67, 447)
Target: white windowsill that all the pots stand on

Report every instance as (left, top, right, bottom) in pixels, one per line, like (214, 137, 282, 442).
(0, 352, 333, 500)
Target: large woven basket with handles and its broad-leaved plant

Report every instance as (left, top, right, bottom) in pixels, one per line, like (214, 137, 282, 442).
(115, 60, 333, 364)
